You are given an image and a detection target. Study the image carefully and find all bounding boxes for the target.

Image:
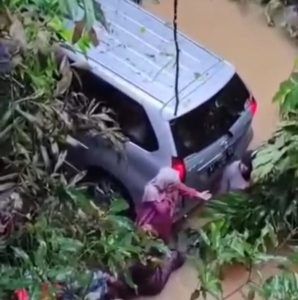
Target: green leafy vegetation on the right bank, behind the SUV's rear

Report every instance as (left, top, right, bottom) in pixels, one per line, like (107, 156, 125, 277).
(191, 65, 298, 300)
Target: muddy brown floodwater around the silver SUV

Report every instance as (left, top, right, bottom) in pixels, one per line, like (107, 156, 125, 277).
(140, 0, 298, 300)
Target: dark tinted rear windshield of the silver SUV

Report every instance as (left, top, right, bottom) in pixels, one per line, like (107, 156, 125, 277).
(171, 74, 249, 158)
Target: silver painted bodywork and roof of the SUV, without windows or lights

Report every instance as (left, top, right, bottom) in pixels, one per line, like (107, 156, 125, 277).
(62, 0, 252, 218)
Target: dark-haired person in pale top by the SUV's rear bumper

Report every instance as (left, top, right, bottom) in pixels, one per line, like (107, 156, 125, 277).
(218, 151, 254, 194)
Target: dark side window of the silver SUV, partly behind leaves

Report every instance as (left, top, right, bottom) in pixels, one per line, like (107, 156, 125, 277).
(76, 72, 158, 152)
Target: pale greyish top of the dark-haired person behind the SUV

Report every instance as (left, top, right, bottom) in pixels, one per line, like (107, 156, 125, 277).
(218, 160, 250, 194)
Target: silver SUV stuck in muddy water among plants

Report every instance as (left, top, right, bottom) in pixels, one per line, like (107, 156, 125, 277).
(67, 0, 256, 216)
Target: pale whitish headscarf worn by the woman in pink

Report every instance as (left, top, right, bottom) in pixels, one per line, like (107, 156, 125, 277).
(142, 167, 181, 202)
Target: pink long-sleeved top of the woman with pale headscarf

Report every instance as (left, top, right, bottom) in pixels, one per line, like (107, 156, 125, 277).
(137, 183, 198, 243)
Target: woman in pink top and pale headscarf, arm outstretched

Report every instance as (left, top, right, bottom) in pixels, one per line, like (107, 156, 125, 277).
(136, 167, 211, 243)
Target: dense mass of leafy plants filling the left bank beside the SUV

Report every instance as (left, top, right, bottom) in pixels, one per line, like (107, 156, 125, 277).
(0, 0, 167, 300)
